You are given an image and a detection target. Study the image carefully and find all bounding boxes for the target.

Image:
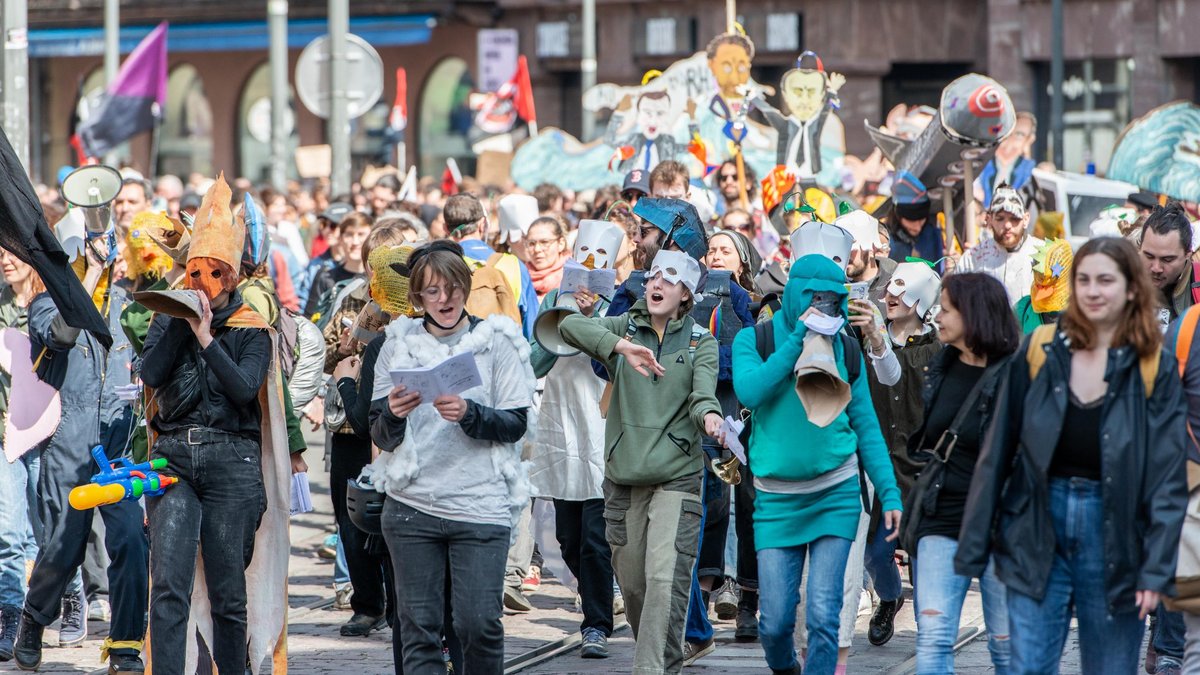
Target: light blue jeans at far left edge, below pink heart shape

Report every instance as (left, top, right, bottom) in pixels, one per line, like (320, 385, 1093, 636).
(0, 452, 42, 607)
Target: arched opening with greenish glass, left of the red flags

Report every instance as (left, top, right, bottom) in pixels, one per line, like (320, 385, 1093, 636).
(418, 56, 474, 175)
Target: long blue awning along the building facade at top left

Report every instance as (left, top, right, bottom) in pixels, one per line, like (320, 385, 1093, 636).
(29, 14, 437, 58)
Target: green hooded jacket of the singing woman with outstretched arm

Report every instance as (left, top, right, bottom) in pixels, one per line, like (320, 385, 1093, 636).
(559, 299, 721, 485)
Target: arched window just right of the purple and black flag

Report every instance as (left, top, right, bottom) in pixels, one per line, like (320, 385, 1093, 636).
(151, 65, 212, 179)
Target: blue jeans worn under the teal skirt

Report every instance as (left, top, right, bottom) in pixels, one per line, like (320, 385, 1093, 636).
(758, 537, 853, 675)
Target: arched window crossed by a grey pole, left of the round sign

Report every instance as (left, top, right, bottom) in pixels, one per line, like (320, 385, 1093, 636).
(238, 64, 300, 183)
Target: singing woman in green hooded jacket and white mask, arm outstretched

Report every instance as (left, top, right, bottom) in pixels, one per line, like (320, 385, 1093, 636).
(559, 251, 721, 674)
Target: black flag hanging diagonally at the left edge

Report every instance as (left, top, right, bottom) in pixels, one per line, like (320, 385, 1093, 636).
(0, 129, 113, 347)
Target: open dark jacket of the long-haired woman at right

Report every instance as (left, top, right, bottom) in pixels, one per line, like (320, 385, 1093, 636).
(954, 333, 1188, 613)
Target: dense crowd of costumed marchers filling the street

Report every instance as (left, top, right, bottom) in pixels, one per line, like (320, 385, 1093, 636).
(0, 133, 1200, 675)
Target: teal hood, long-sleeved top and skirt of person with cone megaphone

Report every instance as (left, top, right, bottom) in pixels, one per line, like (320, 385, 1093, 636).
(733, 256, 901, 550)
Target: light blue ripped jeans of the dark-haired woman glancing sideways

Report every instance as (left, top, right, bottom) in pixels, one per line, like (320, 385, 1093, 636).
(916, 536, 1010, 675)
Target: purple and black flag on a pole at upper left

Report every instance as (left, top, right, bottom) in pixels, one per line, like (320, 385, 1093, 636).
(79, 22, 167, 157)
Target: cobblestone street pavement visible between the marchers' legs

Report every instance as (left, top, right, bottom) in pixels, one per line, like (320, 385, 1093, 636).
(7, 436, 1132, 675)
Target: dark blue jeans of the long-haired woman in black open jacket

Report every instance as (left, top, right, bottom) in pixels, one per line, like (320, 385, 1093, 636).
(1008, 478, 1145, 675)
